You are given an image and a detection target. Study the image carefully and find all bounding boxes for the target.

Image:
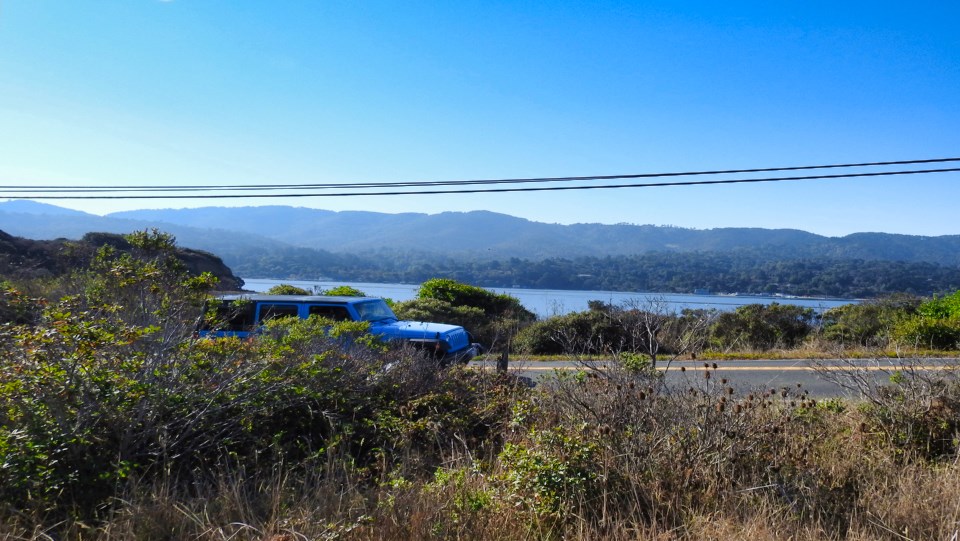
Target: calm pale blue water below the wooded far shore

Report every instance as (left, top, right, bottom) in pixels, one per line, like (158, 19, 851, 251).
(244, 278, 857, 317)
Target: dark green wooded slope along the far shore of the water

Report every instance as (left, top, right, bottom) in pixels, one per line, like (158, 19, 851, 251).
(227, 248, 960, 298)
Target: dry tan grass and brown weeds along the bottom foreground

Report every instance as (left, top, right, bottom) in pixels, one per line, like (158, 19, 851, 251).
(0, 360, 960, 541)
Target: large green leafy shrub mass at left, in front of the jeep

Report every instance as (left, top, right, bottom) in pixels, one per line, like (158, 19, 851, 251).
(0, 232, 520, 517)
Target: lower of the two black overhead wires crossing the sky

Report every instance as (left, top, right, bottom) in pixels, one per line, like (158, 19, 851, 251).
(7, 166, 960, 199)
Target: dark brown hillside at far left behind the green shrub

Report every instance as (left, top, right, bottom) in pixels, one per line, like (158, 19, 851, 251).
(0, 231, 243, 291)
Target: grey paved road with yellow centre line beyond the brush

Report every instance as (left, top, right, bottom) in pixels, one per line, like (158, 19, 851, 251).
(473, 358, 960, 398)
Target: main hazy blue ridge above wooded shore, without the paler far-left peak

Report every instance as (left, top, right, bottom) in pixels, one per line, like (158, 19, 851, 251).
(109, 206, 960, 265)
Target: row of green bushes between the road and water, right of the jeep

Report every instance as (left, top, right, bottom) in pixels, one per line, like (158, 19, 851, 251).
(514, 291, 960, 358)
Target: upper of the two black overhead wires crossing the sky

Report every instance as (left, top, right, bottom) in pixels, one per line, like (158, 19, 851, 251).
(0, 158, 960, 193)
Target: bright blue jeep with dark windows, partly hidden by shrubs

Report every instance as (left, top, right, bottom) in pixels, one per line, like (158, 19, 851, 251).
(197, 294, 480, 363)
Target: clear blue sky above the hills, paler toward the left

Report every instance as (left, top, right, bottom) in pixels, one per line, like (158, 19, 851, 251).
(0, 0, 960, 235)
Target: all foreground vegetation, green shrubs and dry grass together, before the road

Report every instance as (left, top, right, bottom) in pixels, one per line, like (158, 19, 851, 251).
(0, 232, 960, 540)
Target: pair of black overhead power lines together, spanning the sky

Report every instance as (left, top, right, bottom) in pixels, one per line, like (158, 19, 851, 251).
(0, 158, 960, 199)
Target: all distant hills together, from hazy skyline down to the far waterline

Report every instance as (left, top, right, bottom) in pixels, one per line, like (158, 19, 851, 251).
(0, 203, 960, 298)
